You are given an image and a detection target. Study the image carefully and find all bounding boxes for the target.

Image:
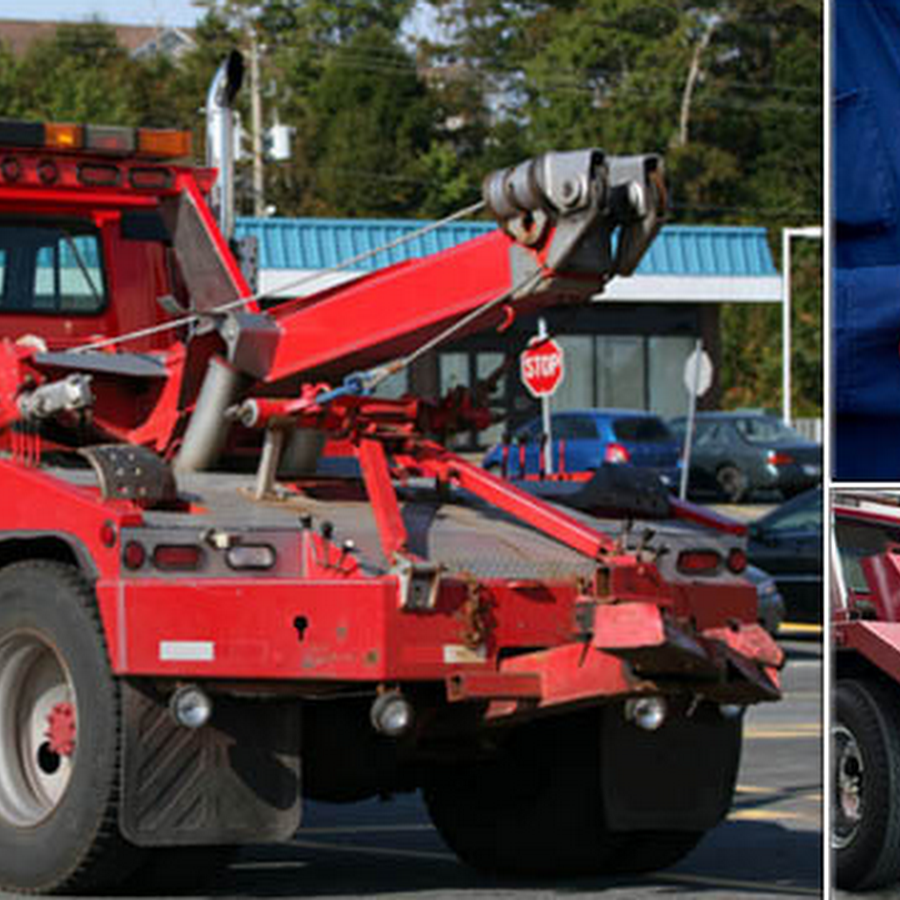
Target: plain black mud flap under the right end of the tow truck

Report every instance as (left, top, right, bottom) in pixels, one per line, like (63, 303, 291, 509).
(601, 703, 742, 831)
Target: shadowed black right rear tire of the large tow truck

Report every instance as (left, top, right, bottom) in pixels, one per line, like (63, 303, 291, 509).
(424, 713, 703, 877)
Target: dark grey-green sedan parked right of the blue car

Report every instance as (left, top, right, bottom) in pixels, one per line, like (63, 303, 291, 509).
(670, 412, 822, 503)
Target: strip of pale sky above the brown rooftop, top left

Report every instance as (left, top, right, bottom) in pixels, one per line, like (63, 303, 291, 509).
(0, 0, 200, 26)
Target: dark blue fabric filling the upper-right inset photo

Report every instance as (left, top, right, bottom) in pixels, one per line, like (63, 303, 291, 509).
(832, 0, 900, 481)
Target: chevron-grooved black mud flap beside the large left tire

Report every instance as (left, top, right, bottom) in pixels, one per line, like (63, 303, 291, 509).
(120, 680, 300, 847)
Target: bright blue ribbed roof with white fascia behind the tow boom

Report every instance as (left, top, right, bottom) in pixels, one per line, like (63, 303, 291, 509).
(236, 218, 781, 303)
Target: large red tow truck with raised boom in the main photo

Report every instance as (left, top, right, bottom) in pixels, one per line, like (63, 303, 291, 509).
(0, 88, 782, 893)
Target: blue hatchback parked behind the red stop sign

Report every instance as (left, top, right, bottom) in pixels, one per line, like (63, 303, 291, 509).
(482, 409, 680, 488)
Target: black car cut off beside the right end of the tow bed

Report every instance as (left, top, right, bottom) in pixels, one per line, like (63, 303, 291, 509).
(747, 488, 823, 622)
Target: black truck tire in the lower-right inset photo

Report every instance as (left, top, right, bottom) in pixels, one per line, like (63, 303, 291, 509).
(831, 679, 900, 890)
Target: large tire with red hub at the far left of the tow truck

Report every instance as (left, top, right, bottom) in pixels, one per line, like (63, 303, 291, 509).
(0, 561, 142, 893)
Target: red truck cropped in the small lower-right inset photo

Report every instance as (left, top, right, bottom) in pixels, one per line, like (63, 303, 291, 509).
(831, 489, 900, 890)
